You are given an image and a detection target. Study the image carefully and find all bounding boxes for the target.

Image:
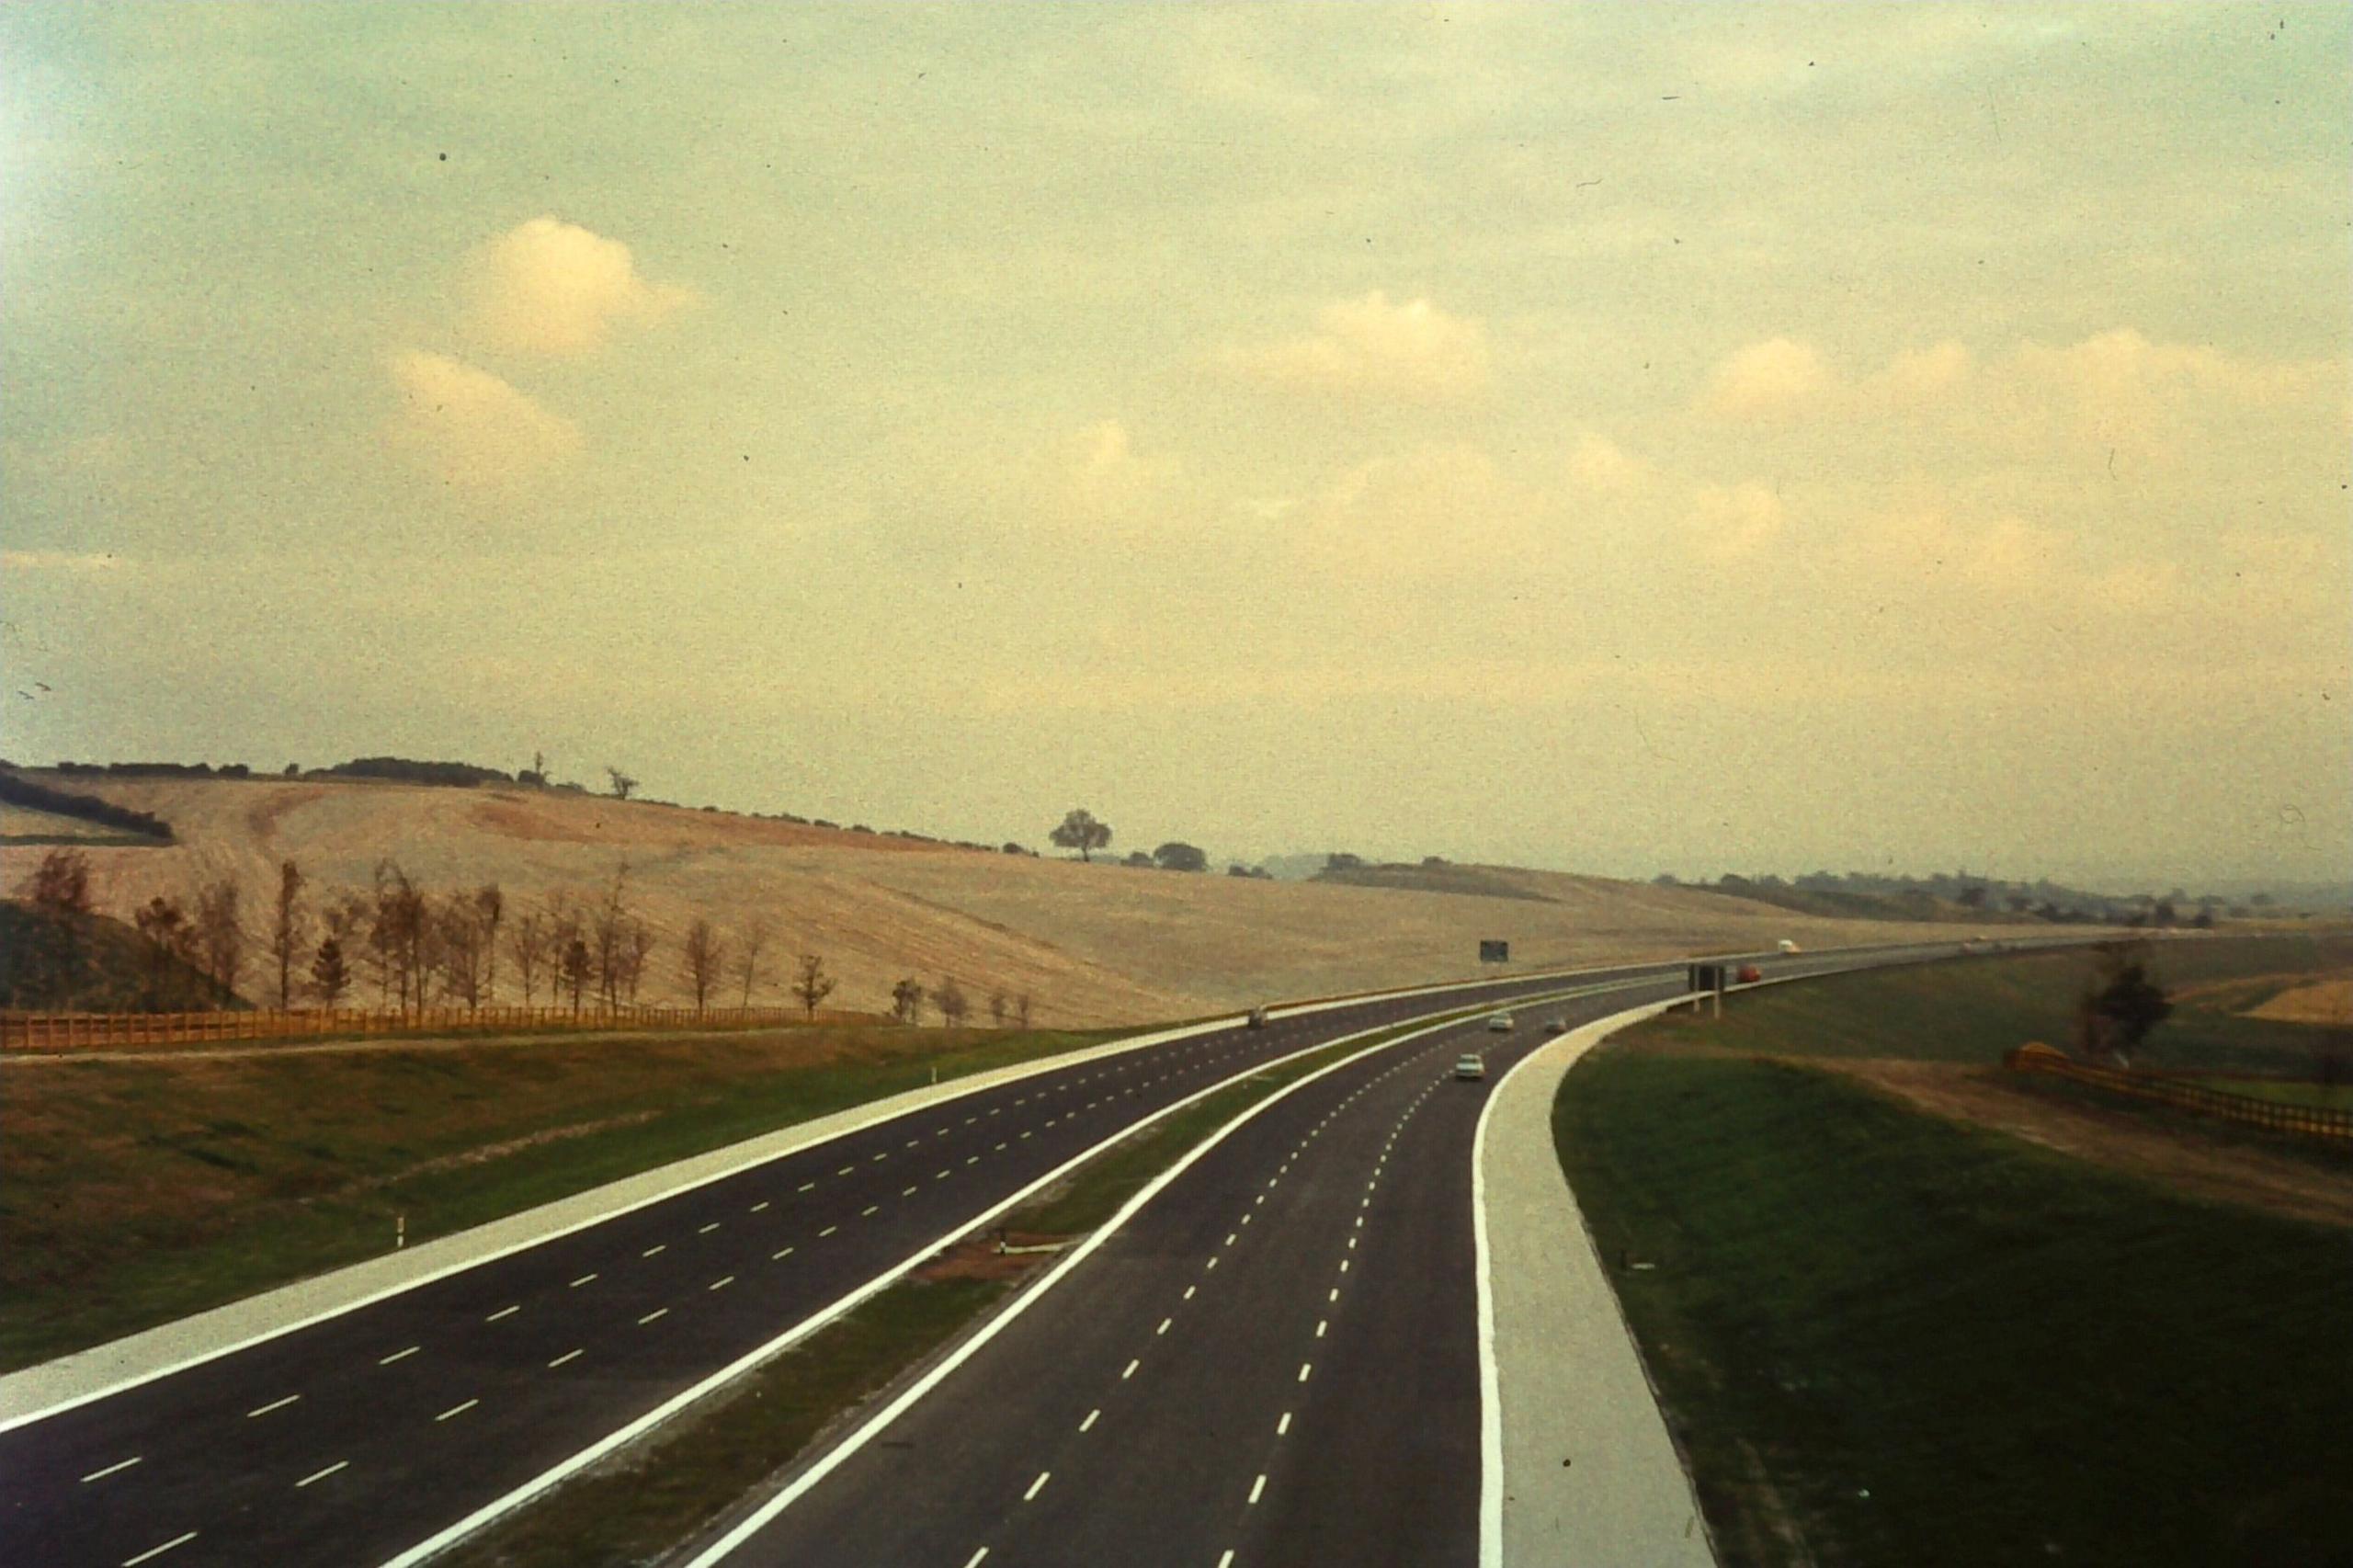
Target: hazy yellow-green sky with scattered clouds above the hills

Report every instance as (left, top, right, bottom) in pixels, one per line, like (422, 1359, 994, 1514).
(0, 5, 2353, 888)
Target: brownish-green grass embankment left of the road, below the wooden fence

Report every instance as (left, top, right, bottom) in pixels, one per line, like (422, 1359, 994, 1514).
(0, 1027, 1129, 1368)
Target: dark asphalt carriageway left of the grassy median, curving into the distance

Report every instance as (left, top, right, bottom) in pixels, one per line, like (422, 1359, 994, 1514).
(0, 950, 1779, 1568)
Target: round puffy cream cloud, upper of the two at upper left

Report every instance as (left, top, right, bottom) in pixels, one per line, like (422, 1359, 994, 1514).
(466, 217, 692, 356)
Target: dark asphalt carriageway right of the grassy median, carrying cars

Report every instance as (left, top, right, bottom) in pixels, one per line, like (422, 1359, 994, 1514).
(697, 947, 1995, 1568)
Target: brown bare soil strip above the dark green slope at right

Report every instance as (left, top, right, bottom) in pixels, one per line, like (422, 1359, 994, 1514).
(1812, 1060, 2353, 1227)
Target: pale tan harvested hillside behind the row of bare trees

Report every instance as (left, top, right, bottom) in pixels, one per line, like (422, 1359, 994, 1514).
(0, 777, 1948, 1027)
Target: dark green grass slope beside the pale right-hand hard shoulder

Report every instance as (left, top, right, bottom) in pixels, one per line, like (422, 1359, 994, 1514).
(1553, 1040, 2353, 1568)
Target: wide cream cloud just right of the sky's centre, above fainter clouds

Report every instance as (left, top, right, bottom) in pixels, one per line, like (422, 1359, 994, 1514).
(1222, 290, 1487, 403)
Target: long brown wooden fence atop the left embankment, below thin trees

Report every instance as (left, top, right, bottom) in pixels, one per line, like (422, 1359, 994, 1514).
(0, 1003, 875, 1050)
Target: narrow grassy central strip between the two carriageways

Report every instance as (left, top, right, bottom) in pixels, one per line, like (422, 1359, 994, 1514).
(447, 1007, 1468, 1568)
